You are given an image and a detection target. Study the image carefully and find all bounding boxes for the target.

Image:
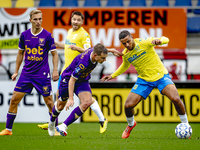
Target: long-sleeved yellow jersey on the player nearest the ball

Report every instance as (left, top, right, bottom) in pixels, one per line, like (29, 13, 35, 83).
(111, 36, 169, 82)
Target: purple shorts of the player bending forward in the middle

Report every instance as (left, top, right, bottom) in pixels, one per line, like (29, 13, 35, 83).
(58, 81, 92, 101)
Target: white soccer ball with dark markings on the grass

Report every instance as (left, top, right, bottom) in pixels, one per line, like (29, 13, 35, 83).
(175, 123, 192, 139)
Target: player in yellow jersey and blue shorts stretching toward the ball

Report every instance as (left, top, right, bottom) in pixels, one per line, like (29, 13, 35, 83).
(101, 30, 188, 138)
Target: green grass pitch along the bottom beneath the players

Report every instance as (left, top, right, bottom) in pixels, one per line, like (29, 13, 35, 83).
(0, 122, 200, 150)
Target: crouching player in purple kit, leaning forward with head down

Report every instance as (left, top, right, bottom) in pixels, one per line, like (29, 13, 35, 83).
(48, 44, 108, 136)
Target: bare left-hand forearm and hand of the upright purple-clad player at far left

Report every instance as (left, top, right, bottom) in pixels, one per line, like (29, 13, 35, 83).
(11, 50, 24, 81)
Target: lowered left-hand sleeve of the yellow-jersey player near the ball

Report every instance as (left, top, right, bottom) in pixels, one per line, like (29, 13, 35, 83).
(111, 56, 131, 78)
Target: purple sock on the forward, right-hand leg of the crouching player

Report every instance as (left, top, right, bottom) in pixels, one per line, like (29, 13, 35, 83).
(63, 106, 83, 126)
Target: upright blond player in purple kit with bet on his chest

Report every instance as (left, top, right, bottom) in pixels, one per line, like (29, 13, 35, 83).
(0, 10, 59, 135)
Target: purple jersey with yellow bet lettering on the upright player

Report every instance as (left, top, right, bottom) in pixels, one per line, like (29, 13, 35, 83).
(19, 29, 56, 77)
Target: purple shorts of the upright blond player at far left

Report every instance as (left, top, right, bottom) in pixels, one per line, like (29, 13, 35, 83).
(14, 74, 52, 97)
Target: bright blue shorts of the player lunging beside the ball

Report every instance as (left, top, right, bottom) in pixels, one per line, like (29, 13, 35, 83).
(131, 74, 174, 99)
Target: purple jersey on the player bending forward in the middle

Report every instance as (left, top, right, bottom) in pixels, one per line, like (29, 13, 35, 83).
(61, 48, 98, 82)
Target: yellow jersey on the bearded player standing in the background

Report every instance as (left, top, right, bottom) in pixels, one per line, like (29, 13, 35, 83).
(62, 27, 91, 72)
